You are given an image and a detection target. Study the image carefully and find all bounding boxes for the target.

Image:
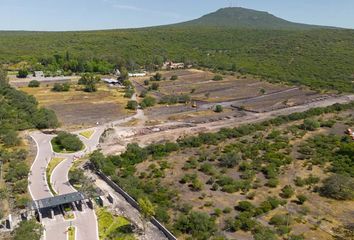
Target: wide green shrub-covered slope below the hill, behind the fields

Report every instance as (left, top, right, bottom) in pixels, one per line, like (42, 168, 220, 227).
(0, 26, 354, 92)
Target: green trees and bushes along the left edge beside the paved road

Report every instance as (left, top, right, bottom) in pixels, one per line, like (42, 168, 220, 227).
(0, 68, 58, 225)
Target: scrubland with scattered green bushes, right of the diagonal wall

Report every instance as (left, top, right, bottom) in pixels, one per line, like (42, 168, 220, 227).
(90, 103, 354, 239)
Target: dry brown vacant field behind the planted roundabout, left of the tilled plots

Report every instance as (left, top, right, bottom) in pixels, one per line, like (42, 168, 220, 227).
(20, 84, 133, 129)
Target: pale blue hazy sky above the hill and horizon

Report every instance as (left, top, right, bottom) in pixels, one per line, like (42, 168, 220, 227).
(0, 0, 354, 31)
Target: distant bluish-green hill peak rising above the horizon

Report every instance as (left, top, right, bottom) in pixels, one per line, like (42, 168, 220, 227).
(174, 7, 328, 29)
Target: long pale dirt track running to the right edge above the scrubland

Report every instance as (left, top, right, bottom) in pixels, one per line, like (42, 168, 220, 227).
(102, 95, 354, 154)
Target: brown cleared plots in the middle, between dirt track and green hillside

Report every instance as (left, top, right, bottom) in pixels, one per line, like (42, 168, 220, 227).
(133, 69, 330, 122)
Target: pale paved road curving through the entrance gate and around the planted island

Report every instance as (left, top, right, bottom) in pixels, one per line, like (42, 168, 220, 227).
(28, 110, 144, 240)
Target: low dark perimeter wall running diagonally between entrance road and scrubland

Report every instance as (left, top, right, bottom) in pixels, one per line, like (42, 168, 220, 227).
(96, 171, 177, 240)
